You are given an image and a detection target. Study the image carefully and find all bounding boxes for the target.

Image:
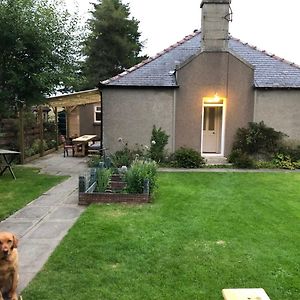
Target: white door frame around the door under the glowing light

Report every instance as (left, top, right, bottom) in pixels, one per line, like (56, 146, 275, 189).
(201, 97, 226, 156)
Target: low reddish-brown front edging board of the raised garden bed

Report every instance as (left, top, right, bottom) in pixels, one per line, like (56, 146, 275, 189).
(78, 193, 150, 205)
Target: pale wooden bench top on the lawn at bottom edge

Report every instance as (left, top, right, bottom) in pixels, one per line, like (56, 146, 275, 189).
(222, 288, 270, 300)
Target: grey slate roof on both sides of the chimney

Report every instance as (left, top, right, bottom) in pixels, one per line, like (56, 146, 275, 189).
(100, 31, 300, 88)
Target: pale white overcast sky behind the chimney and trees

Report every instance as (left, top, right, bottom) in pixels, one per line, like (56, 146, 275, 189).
(66, 0, 300, 65)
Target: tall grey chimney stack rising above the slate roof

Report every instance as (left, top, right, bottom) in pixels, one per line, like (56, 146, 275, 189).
(200, 0, 232, 52)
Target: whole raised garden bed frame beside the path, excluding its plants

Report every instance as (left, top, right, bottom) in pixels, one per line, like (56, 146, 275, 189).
(78, 169, 151, 205)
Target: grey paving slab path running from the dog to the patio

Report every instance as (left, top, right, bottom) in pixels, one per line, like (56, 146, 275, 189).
(0, 151, 88, 293)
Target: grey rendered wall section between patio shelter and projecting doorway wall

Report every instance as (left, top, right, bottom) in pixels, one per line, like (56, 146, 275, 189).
(102, 88, 174, 153)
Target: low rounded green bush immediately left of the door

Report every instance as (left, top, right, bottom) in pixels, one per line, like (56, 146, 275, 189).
(171, 147, 205, 168)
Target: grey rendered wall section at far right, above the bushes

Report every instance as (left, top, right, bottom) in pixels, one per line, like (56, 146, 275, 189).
(254, 90, 300, 140)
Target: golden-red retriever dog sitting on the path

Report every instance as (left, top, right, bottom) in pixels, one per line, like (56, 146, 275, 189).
(0, 232, 19, 300)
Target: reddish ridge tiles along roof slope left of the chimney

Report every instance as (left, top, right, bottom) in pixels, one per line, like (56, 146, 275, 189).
(100, 30, 201, 84)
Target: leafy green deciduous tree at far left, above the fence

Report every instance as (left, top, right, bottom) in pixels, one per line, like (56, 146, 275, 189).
(0, 0, 79, 115)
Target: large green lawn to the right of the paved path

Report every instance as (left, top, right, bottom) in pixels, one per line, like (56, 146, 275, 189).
(23, 173, 300, 300)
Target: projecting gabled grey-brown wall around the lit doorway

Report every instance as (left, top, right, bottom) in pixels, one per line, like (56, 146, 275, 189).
(175, 52, 254, 156)
